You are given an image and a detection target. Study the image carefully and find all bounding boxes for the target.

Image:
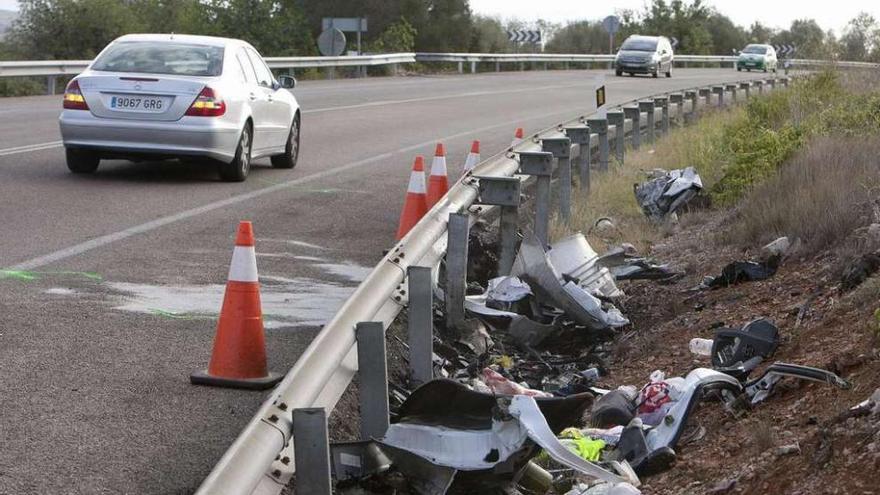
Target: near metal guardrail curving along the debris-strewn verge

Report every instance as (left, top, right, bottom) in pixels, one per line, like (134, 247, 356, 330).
(197, 74, 796, 495)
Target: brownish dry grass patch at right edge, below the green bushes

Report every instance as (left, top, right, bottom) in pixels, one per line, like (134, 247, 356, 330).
(721, 137, 880, 251)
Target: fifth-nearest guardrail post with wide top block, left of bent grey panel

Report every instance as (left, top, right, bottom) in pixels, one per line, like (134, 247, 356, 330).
(477, 177, 522, 277)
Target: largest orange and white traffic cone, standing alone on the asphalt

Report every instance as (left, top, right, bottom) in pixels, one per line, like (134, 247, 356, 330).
(190, 222, 282, 390)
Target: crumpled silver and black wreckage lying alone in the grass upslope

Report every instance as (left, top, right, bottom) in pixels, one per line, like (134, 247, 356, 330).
(634, 167, 703, 220)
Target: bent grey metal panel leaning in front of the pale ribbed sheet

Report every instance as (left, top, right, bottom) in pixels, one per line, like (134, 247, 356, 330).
(511, 234, 628, 330)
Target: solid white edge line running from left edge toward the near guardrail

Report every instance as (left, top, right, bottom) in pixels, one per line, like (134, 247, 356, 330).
(6, 105, 578, 270)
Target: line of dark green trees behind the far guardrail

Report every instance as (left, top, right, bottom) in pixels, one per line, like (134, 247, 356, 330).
(0, 0, 880, 96)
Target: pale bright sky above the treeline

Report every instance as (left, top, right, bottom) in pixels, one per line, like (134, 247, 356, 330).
(0, 0, 880, 33)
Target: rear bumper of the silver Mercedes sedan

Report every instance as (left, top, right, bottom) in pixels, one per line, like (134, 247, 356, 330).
(59, 110, 241, 161)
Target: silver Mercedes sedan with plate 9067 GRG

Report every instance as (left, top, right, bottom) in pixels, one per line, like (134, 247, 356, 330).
(60, 34, 300, 181)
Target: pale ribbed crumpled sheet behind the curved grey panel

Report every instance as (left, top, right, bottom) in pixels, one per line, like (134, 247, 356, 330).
(547, 232, 624, 298)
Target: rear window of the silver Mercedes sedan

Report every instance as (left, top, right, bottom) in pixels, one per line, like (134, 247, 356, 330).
(92, 41, 223, 76)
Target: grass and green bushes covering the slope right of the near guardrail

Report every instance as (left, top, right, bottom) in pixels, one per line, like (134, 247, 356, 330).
(554, 71, 880, 260)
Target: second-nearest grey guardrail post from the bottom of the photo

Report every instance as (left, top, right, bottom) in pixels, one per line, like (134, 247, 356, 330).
(355, 324, 388, 440)
